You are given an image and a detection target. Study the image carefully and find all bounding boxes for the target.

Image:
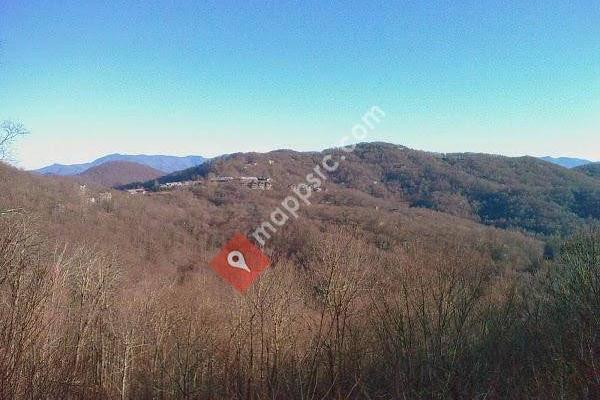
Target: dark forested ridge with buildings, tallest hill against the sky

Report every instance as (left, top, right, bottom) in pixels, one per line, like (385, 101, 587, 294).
(136, 143, 600, 235)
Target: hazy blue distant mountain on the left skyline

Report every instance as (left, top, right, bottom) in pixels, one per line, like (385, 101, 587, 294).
(33, 154, 206, 176)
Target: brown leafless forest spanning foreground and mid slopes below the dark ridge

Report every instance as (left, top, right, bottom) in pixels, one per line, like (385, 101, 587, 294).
(0, 155, 600, 399)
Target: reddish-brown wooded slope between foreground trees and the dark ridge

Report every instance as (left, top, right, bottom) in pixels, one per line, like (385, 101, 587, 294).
(0, 159, 542, 271)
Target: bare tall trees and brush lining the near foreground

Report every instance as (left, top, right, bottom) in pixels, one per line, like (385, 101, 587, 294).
(0, 212, 600, 399)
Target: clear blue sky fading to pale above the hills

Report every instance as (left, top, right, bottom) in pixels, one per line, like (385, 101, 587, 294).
(0, 0, 600, 168)
